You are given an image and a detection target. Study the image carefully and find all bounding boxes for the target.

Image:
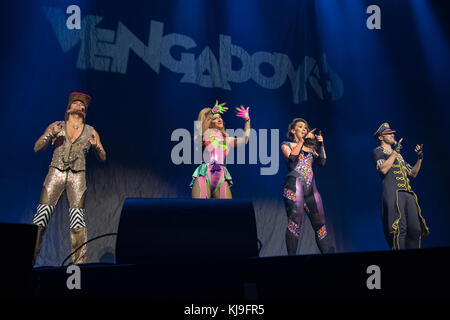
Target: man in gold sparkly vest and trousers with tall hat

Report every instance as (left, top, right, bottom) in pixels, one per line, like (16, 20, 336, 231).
(33, 92, 106, 264)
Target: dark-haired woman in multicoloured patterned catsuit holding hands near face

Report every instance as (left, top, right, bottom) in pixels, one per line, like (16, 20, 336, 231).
(281, 118, 328, 255)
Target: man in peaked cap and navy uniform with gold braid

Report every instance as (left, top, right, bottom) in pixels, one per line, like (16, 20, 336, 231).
(373, 122, 430, 249)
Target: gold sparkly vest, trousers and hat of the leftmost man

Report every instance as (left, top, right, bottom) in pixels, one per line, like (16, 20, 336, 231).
(33, 93, 98, 264)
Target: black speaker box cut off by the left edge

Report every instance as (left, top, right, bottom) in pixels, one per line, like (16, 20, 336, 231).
(0, 223, 37, 298)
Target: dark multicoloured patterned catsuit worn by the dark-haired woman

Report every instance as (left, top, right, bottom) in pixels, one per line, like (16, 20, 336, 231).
(282, 141, 328, 255)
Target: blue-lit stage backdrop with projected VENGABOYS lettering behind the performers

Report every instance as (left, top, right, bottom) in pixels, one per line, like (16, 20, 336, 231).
(0, 0, 450, 265)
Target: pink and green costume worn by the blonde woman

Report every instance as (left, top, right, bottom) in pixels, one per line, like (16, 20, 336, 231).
(190, 132, 234, 199)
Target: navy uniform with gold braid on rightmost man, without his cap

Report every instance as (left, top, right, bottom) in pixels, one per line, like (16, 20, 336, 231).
(373, 146, 430, 249)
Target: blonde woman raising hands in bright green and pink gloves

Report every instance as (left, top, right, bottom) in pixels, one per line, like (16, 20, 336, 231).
(190, 101, 250, 199)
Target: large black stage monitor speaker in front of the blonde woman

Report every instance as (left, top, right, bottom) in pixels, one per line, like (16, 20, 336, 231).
(116, 198, 258, 264)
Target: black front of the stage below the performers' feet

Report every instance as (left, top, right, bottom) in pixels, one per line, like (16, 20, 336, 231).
(7, 247, 450, 303)
